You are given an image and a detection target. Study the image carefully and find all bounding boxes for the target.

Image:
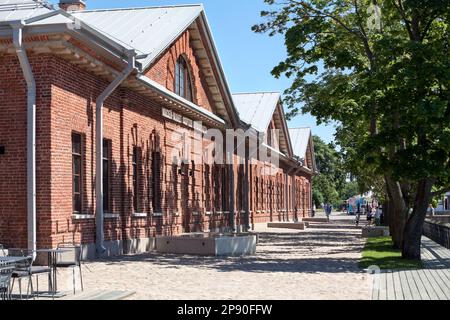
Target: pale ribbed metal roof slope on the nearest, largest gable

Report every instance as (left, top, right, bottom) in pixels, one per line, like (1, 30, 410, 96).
(70, 5, 203, 61)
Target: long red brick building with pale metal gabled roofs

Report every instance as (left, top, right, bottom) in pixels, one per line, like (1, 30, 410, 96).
(0, 0, 315, 256)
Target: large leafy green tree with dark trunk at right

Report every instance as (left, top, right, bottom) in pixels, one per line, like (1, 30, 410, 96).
(253, 0, 450, 259)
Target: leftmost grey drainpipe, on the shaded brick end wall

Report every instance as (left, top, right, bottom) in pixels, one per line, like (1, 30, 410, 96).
(10, 21, 36, 257)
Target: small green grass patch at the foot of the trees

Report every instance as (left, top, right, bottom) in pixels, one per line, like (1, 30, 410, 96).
(359, 237, 422, 270)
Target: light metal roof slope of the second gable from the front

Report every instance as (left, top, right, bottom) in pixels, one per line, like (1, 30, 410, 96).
(233, 92, 280, 133)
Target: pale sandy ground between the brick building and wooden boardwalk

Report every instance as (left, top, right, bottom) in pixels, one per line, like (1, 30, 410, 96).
(19, 217, 371, 300)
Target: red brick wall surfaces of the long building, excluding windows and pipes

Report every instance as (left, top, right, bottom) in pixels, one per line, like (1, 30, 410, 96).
(0, 38, 310, 247)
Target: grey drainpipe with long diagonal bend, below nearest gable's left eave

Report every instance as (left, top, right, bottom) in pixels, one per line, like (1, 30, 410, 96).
(95, 50, 136, 256)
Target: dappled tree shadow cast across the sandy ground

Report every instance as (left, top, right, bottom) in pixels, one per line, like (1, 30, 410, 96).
(86, 221, 364, 273)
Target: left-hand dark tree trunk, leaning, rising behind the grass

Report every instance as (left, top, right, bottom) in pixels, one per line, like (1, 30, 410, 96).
(385, 176, 408, 249)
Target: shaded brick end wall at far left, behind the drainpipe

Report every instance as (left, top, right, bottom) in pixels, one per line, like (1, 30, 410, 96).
(0, 55, 52, 247)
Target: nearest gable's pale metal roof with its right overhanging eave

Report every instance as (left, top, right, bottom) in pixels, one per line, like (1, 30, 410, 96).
(14, 5, 239, 127)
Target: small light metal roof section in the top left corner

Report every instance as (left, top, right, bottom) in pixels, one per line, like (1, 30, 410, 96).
(0, 0, 51, 22)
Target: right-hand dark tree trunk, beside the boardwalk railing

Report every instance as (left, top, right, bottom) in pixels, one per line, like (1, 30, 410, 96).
(402, 179, 434, 260)
